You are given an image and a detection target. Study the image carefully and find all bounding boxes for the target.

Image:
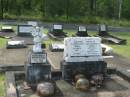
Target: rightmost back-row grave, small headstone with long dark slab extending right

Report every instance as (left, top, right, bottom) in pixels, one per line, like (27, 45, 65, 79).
(98, 24, 126, 44)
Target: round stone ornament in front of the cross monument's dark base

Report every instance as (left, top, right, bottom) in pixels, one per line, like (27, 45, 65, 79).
(37, 82, 55, 97)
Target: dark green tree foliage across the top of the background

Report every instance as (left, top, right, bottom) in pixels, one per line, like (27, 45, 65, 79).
(0, 0, 130, 19)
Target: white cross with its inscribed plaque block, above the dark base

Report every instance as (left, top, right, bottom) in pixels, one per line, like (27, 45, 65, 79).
(30, 27, 47, 64)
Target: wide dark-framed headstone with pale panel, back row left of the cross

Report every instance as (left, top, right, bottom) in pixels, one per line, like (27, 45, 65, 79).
(18, 25, 33, 36)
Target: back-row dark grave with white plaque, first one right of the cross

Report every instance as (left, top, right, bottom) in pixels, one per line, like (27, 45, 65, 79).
(48, 24, 67, 40)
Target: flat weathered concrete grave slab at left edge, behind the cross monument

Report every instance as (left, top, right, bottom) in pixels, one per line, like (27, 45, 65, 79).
(0, 48, 29, 66)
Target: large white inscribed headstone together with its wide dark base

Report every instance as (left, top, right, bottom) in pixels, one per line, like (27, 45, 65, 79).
(61, 37, 107, 88)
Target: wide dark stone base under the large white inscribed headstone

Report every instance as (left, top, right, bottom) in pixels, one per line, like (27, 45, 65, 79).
(61, 61, 107, 80)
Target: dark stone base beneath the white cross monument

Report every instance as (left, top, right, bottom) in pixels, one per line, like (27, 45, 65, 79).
(25, 64, 51, 89)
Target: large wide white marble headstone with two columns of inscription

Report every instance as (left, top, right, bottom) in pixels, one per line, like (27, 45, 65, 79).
(64, 37, 103, 62)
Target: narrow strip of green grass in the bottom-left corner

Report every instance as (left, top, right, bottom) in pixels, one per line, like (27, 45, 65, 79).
(0, 73, 5, 97)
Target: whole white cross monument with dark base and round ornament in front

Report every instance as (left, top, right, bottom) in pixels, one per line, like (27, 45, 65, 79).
(26, 27, 54, 96)
